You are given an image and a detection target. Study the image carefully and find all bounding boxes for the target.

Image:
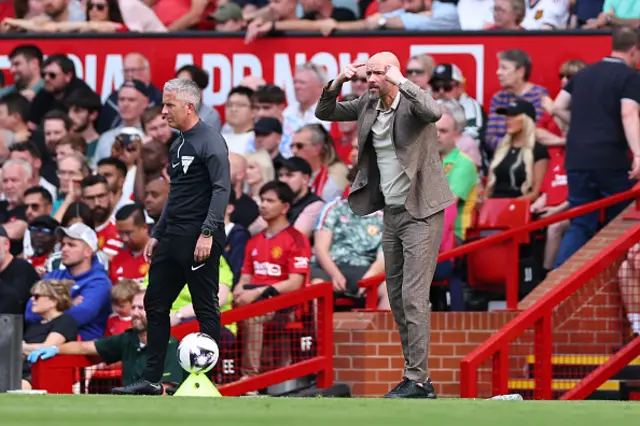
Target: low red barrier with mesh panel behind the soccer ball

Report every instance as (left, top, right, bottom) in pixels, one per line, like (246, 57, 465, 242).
(32, 283, 333, 396)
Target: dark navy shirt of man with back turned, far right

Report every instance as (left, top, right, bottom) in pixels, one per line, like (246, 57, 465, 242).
(563, 57, 640, 172)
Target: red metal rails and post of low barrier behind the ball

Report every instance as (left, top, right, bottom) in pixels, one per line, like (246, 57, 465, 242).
(31, 283, 333, 396)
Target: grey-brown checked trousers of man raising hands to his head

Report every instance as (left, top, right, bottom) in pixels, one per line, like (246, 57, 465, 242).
(382, 206, 444, 383)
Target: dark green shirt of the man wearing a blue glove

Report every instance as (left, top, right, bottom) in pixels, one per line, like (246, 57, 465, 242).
(95, 329, 184, 386)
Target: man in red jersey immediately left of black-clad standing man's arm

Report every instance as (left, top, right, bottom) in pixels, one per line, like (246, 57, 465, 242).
(109, 203, 150, 284)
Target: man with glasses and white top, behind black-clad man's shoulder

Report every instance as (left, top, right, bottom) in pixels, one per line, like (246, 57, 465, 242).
(220, 85, 255, 155)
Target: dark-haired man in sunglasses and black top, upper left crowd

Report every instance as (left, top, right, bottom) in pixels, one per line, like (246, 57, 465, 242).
(28, 54, 98, 130)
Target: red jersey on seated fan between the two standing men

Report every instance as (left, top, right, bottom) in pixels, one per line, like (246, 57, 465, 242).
(242, 226, 311, 285)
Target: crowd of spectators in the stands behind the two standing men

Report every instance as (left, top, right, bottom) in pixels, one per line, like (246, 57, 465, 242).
(0, 0, 640, 394)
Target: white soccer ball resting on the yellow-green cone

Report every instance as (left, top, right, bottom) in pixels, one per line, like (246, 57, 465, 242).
(178, 333, 220, 374)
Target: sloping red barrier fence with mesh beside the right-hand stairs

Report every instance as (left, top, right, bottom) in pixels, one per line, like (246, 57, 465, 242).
(460, 225, 640, 399)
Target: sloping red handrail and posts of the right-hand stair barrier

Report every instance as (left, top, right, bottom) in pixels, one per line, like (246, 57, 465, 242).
(460, 223, 640, 399)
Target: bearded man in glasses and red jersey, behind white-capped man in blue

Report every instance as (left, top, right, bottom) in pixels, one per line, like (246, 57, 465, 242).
(80, 175, 123, 258)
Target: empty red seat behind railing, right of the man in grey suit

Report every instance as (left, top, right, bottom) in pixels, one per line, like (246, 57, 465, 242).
(467, 198, 531, 292)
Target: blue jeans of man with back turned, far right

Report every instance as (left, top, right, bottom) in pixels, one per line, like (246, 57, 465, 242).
(554, 170, 633, 268)
